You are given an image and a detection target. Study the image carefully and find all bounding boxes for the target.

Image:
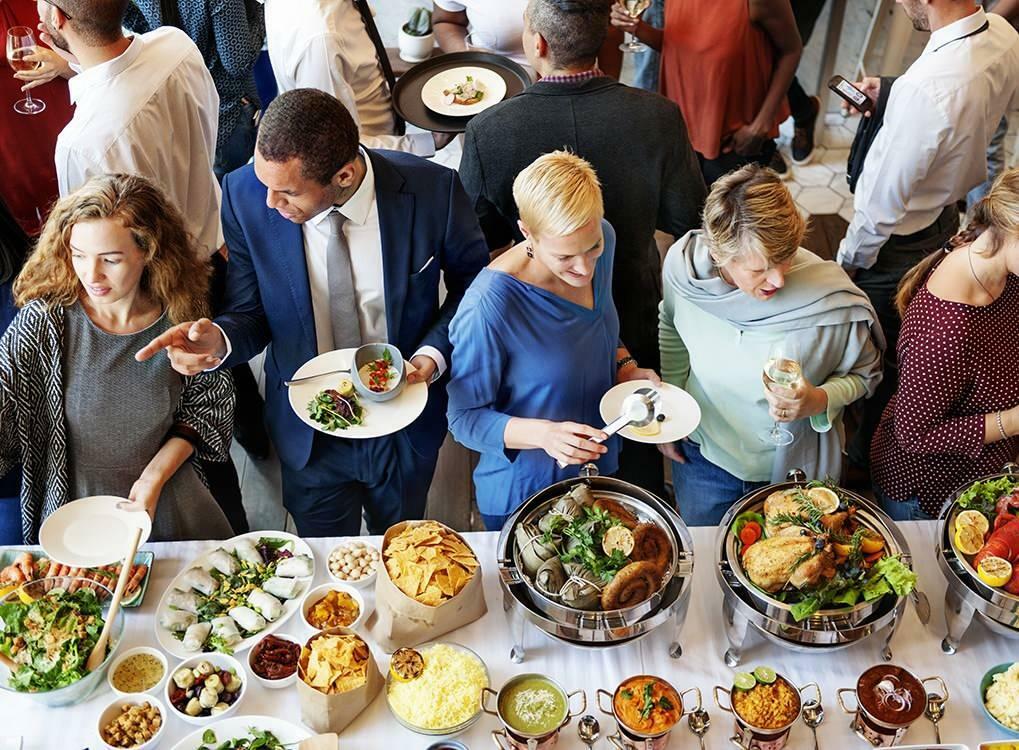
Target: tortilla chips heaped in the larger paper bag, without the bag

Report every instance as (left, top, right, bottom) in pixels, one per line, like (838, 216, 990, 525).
(382, 521, 478, 606)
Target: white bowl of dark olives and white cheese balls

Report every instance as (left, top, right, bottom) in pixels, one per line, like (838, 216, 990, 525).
(166, 653, 248, 725)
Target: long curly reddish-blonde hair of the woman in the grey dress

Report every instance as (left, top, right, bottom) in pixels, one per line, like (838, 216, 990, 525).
(14, 174, 212, 323)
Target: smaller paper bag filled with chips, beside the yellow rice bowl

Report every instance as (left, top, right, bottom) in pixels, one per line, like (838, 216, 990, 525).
(298, 628, 385, 734)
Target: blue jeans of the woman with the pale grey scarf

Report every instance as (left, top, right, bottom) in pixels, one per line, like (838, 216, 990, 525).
(673, 440, 767, 526)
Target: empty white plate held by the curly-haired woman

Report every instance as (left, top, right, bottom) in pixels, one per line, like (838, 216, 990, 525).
(39, 495, 152, 568)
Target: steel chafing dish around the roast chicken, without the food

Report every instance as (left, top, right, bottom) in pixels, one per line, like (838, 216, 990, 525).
(715, 470, 929, 666)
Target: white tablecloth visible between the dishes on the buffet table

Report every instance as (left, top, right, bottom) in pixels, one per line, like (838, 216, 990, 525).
(0, 523, 1019, 750)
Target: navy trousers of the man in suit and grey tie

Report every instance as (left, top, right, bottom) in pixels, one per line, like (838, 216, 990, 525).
(281, 433, 438, 537)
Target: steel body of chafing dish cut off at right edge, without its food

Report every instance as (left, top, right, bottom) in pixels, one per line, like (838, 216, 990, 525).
(936, 464, 1019, 654)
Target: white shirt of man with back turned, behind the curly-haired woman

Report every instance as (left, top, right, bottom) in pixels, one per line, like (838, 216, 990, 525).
(56, 26, 223, 255)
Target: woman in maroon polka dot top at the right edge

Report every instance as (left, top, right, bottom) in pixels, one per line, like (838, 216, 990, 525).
(870, 168, 1019, 520)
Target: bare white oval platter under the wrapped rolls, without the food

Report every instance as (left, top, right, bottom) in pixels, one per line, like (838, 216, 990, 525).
(153, 531, 315, 659)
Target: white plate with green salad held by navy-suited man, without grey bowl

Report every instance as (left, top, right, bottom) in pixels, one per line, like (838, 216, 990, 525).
(288, 349, 428, 440)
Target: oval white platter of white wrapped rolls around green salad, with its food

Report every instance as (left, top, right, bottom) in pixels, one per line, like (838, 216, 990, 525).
(155, 531, 315, 659)
